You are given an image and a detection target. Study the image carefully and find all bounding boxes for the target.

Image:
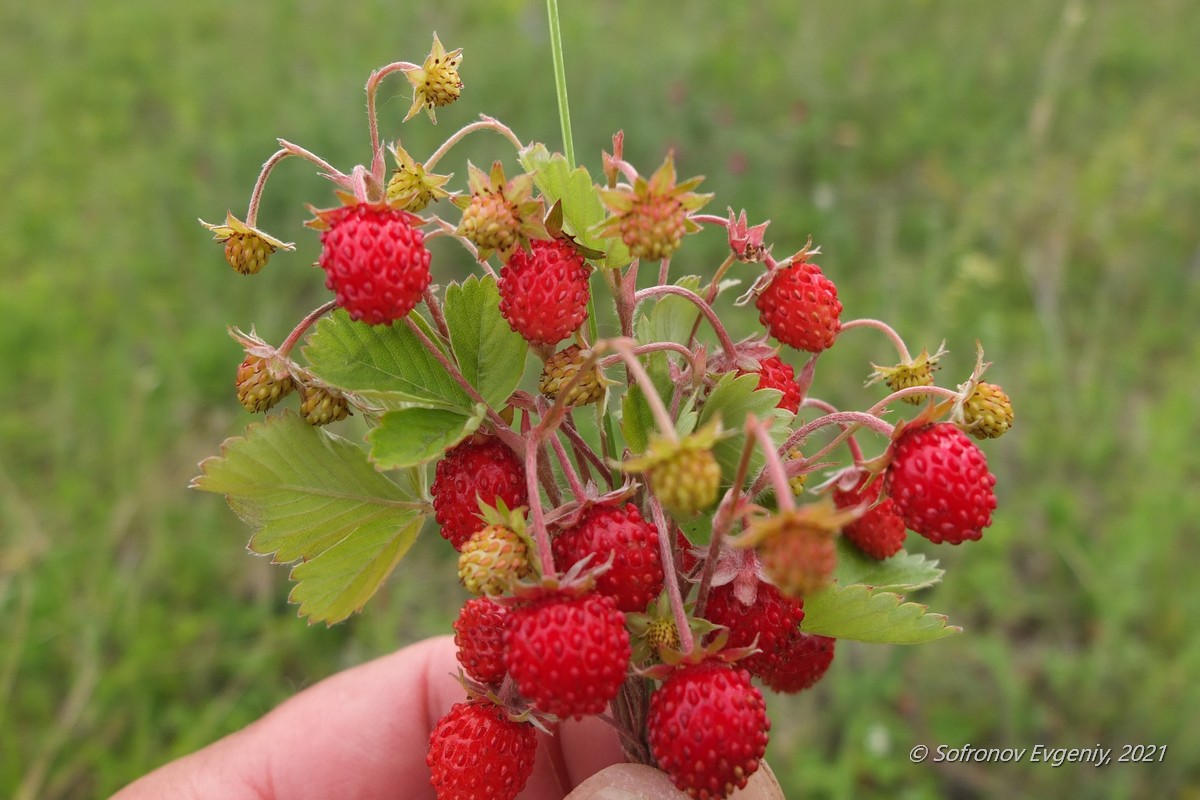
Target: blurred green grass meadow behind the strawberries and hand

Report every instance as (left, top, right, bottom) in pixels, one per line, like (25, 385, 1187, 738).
(0, 0, 1200, 798)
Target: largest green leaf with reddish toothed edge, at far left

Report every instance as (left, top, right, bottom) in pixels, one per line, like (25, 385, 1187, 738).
(192, 411, 428, 624)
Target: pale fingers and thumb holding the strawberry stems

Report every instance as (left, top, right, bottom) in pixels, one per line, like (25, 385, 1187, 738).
(113, 637, 784, 800)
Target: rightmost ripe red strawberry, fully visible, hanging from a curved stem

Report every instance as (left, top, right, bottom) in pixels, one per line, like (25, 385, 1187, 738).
(884, 422, 996, 545)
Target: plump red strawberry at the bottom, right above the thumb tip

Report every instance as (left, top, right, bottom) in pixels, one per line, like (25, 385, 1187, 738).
(646, 661, 770, 800)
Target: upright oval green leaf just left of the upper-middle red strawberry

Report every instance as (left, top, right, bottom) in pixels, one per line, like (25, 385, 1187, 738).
(445, 275, 529, 408)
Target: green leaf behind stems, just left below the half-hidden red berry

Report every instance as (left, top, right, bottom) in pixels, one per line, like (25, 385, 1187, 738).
(700, 372, 793, 481)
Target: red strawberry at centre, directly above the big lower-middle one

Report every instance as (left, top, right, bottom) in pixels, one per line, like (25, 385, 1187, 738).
(553, 504, 662, 612)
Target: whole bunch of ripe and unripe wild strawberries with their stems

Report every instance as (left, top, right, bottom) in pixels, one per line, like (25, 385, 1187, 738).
(199, 36, 1013, 799)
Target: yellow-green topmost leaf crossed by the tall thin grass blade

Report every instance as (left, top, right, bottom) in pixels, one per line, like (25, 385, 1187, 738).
(520, 144, 630, 267)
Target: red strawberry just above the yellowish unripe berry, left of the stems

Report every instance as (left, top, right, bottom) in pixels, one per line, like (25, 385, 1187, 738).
(430, 439, 529, 551)
